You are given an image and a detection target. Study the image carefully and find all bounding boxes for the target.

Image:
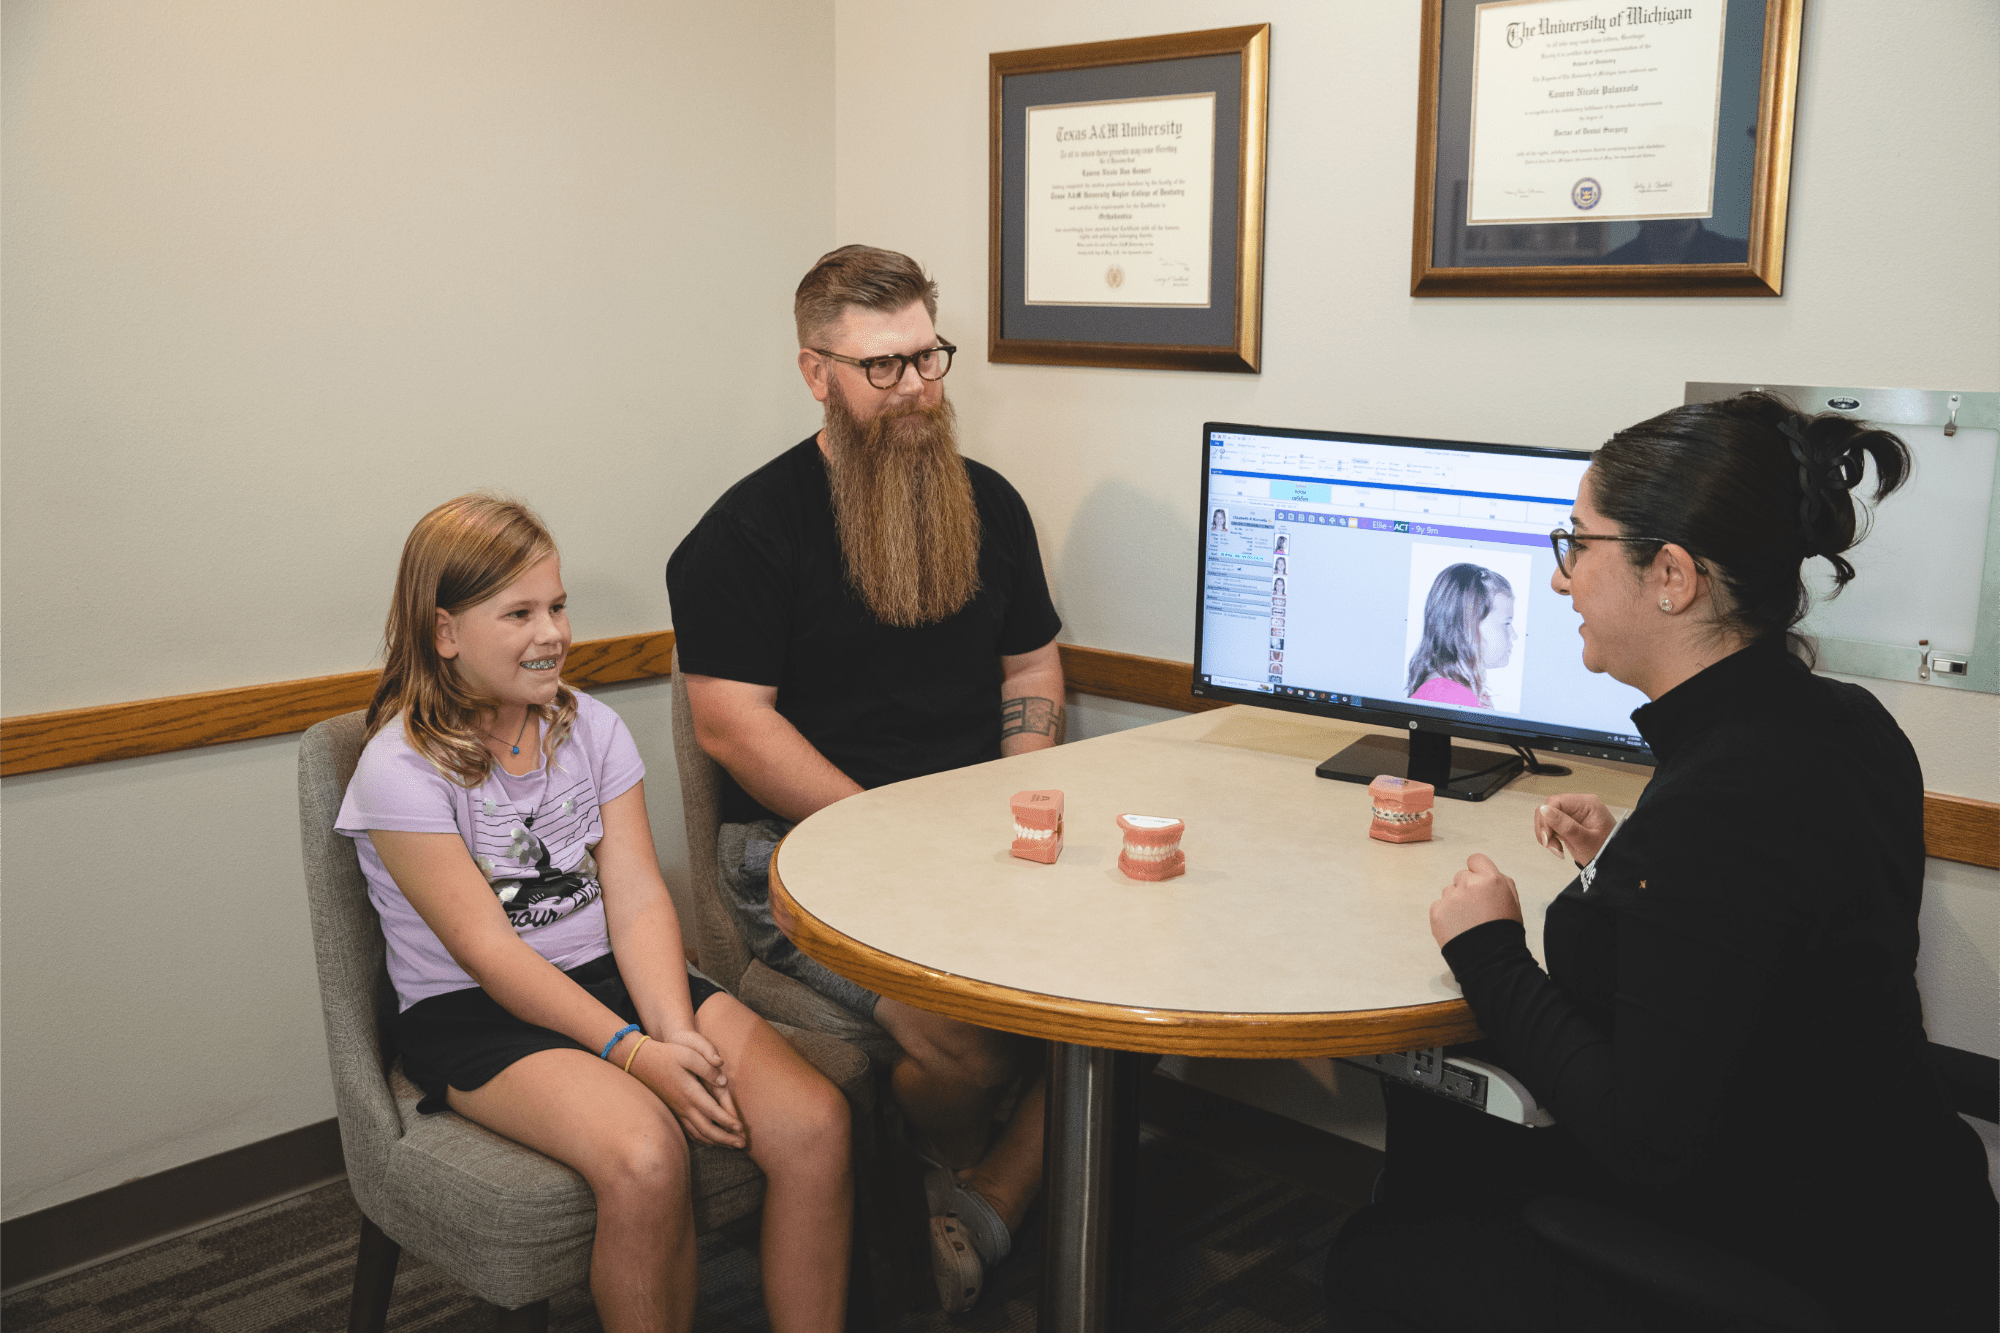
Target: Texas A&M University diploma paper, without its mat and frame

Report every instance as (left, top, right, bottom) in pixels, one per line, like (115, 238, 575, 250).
(1024, 92, 1216, 306)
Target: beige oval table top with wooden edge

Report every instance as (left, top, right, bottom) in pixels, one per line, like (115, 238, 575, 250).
(772, 707, 1650, 1057)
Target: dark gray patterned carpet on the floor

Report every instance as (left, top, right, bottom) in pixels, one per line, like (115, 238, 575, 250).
(0, 1137, 1348, 1333)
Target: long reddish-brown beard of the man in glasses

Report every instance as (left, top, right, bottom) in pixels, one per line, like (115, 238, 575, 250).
(826, 382, 980, 628)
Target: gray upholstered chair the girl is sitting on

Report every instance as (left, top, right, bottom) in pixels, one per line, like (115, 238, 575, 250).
(298, 713, 874, 1333)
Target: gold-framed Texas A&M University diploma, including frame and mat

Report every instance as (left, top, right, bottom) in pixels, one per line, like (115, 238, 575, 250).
(986, 24, 1270, 372)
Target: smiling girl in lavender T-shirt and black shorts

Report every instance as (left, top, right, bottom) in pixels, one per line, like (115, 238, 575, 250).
(338, 494, 852, 1333)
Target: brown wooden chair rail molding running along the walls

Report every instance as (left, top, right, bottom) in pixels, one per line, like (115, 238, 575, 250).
(0, 630, 2000, 871)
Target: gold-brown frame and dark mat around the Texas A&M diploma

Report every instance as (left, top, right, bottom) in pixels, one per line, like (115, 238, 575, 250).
(986, 24, 1270, 374)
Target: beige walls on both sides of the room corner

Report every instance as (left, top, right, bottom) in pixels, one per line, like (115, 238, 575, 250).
(0, 0, 2000, 1217)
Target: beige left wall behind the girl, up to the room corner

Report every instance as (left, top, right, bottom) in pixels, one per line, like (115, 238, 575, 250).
(0, 0, 832, 1217)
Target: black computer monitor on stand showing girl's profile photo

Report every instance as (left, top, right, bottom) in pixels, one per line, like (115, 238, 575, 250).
(1194, 422, 1652, 801)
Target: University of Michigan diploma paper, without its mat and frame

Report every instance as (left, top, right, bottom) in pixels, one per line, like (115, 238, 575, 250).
(1466, 0, 1728, 226)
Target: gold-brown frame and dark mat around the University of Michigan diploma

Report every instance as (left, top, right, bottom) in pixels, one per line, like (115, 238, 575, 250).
(1410, 0, 1804, 296)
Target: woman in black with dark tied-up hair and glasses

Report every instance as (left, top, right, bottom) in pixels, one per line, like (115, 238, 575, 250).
(1328, 394, 2000, 1333)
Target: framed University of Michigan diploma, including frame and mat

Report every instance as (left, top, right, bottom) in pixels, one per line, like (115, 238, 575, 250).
(1410, 0, 1804, 296)
